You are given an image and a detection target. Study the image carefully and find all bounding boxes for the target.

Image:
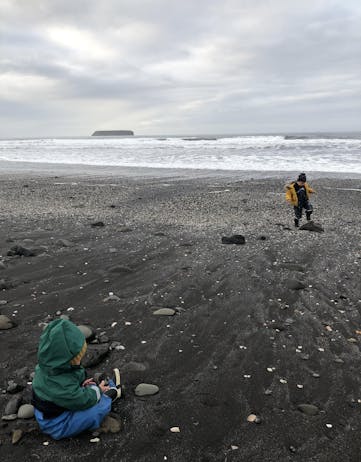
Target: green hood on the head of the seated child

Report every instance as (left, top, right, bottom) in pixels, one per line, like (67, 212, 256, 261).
(38, 319, 85, 375)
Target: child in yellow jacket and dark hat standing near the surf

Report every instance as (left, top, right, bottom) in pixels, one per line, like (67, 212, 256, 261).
(286, 173, 315, 227)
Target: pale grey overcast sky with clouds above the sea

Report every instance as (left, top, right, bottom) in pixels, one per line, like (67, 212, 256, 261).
(0, 0, 361, 138)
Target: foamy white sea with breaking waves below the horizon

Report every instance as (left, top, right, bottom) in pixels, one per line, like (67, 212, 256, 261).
(0, 132, 361, 174)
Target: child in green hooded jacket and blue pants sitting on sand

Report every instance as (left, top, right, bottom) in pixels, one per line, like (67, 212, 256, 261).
(32, 319, 121, 440)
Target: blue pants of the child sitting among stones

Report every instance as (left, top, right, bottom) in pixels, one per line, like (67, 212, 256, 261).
(35, 382, 114, 440)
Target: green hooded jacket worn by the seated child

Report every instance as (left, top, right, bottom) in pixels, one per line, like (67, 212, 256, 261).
(32, 319, 100, 411)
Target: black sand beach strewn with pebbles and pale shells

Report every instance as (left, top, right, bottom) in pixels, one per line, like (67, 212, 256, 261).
(0, 169, 361, 462)
